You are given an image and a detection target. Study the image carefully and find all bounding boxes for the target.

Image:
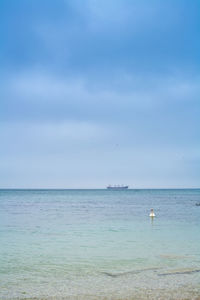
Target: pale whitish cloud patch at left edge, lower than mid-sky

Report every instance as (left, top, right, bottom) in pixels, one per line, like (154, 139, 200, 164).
(0, 121, 109, 157)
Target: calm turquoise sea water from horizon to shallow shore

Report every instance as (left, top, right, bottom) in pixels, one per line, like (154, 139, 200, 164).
(0, 189, 200, 300)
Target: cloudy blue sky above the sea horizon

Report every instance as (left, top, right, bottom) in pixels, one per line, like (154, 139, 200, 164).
(0, 0, 200, 188)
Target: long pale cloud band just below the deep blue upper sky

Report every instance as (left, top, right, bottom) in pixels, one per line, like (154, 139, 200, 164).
(1, 70, 200, 106)
